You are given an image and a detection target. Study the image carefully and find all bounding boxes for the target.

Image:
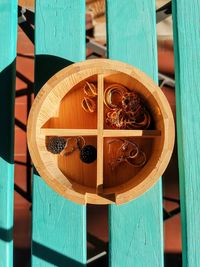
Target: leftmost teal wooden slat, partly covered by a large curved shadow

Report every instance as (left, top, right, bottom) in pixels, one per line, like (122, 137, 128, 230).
(0, 0, 17, 267)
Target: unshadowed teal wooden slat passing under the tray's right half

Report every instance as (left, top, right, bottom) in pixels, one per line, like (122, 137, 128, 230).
(107, 0, 163, 267)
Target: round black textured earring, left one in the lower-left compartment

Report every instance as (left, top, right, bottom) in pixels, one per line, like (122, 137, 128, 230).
(47, 136, 66, 154)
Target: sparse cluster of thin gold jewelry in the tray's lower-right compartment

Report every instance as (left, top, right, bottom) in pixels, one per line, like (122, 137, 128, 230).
(108, 139, 147, 170)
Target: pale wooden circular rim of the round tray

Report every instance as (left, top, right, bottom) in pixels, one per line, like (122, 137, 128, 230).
(27, 59, 175, 204)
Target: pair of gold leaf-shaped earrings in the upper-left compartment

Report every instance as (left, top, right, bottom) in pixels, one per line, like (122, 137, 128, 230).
(81, 82, 97, 113)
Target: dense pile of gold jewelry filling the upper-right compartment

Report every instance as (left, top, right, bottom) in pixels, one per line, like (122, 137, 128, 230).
(104, 84, 151, 129)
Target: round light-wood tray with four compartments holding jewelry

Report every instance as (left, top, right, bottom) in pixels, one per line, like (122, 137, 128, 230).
(27, 59, 175, 204)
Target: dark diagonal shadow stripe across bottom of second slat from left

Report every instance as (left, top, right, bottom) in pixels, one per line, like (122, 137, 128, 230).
(32, 241, 86, 267)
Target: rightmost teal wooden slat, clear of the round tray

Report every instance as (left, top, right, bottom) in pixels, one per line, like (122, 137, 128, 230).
(173, 0, 200, 267)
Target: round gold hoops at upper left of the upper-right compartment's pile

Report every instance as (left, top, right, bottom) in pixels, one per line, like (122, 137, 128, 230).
(104, 83, 128, 109)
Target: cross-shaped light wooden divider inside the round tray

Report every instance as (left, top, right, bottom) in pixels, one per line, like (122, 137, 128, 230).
(40, 74, 161, 197)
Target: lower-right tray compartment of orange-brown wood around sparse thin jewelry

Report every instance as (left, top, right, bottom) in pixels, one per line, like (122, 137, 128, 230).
(103, 136, 161, 189)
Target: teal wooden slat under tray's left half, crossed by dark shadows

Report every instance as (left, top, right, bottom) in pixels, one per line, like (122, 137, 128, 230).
(32, 0, 86, 267)
